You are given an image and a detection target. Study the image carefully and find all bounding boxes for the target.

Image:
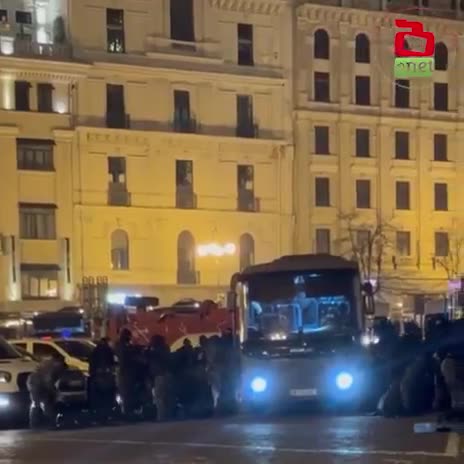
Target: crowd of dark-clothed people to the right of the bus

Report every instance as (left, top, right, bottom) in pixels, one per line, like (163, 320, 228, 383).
(376, 318, 464, 418)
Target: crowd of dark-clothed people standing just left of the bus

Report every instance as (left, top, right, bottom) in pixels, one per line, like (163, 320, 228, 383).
(109, 329, 239, 420)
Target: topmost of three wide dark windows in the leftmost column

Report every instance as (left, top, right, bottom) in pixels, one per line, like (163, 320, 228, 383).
(16, 139, 54, 171)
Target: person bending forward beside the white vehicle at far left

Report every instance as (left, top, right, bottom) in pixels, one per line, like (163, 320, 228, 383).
(27, 354, 67, 428)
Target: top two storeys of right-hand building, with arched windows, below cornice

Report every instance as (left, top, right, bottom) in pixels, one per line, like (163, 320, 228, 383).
(294, 4, 464, 114)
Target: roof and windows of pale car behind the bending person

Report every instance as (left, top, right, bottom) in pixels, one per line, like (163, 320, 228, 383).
(10, 337, 95, 373)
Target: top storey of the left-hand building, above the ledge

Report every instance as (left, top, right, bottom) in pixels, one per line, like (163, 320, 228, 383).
(0, 0, 291, 75)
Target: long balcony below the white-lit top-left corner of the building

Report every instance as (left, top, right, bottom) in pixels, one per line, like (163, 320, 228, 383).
(0, 37, 72, 61)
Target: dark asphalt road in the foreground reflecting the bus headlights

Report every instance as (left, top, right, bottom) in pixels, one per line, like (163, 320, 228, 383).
(0, 417, 464, 464)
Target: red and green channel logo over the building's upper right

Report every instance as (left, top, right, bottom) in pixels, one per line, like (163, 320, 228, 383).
(393, 19, 435, 79)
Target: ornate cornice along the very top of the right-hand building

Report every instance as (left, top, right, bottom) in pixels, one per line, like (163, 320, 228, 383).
(297, 4, 464, 40)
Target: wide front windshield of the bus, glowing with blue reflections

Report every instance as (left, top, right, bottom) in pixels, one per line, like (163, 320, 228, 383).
(244, 270, 359, 340)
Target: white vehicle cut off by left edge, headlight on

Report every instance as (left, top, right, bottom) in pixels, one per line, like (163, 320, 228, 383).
(0, 337, 37, 422)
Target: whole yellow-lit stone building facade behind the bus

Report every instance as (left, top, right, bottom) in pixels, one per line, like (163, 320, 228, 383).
(0, 0, 464, 311)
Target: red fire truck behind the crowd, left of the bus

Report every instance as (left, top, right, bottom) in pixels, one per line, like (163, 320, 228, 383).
(107, 297, 233, 350)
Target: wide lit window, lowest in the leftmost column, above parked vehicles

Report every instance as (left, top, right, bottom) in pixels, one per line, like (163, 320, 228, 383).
(21, 264, 59, 300)
